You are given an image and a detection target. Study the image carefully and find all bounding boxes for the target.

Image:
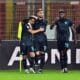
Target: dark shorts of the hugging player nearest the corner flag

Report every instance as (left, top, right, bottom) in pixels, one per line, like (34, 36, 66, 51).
(20, 36, 34, 55)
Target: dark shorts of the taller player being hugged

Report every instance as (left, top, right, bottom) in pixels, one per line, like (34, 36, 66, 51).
(34, 36, 48, 52)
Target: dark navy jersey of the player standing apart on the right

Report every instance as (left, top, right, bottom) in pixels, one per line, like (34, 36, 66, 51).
(55, 18, 73, 41)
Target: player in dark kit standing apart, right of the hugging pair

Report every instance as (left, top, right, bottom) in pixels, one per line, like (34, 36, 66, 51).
(51, 9, 76, 73)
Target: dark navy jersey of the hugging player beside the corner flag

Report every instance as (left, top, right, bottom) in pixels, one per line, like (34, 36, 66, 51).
(21, 24, 32, 39)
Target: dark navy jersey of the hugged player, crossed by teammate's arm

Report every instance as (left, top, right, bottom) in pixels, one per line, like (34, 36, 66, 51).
(33, 19, 47, 39)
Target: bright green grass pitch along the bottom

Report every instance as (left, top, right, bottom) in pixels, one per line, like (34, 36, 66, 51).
(0, 70, 80, 80)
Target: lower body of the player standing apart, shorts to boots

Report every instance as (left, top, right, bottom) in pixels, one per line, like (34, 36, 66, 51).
(59, 42, 69, 73)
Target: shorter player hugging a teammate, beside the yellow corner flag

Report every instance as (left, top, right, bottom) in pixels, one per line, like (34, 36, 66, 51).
(20, 16, 44, 73)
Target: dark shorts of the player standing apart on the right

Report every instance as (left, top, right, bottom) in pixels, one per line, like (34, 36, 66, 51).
(57, 41, 70, 51)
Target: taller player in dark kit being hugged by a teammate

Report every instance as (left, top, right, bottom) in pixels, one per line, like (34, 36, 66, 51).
(33, 9, 47, 72)
